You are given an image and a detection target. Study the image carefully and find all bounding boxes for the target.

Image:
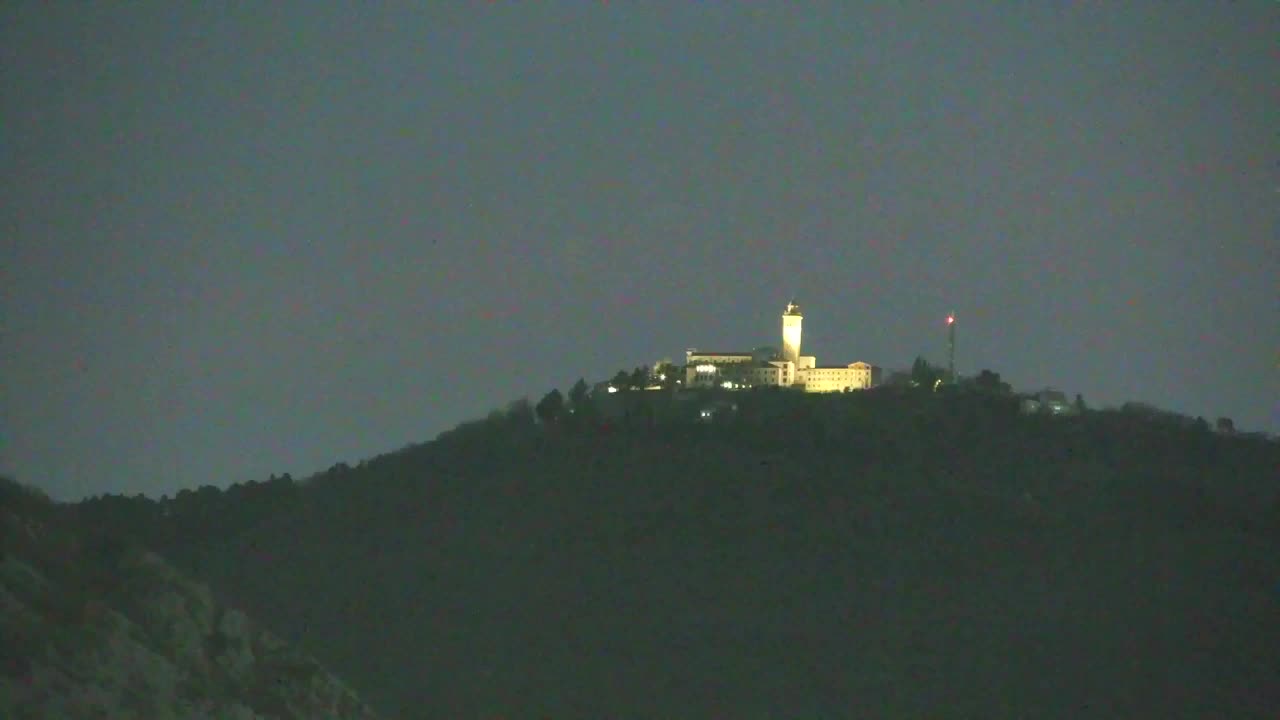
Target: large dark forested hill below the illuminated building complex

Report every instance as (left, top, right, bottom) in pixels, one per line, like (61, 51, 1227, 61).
(72, 391, 1280, 717)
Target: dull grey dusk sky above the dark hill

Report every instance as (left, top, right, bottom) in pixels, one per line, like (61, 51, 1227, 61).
(0, 0, 1280, 500)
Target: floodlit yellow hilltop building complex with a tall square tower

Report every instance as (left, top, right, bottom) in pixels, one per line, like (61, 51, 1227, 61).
(684, 302, 881, 392)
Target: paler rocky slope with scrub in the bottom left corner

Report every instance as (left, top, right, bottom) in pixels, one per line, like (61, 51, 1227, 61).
(0, 478, 375, 720)
